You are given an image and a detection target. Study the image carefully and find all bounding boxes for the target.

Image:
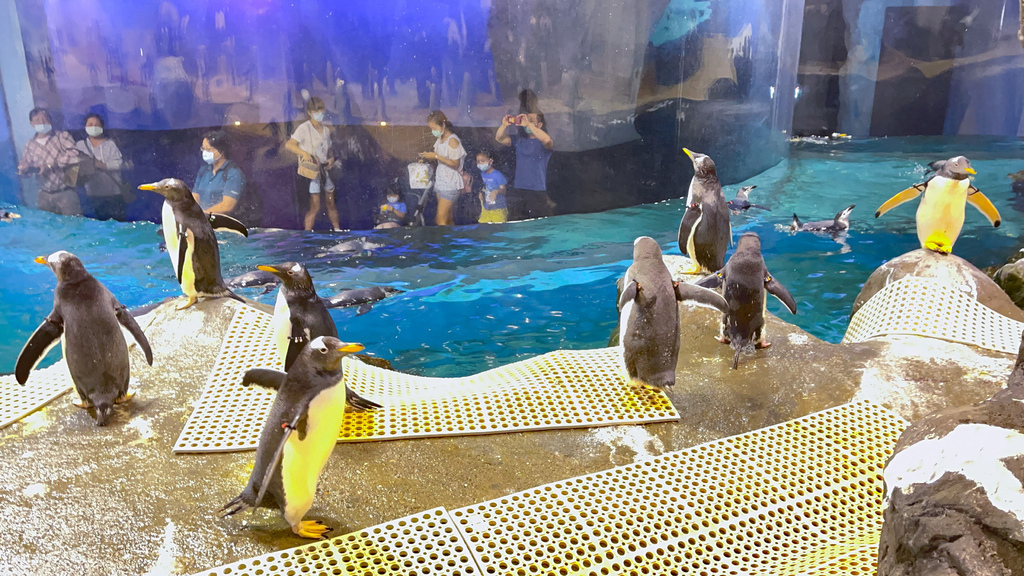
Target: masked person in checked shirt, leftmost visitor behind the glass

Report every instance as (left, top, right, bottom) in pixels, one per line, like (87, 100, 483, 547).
(17, 108, 82, 216)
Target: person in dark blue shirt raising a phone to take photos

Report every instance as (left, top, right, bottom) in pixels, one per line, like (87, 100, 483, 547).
(495, 112, 556, 218)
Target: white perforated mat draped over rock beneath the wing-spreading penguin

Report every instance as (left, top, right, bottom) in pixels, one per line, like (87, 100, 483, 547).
(843, 276, 1024, 354)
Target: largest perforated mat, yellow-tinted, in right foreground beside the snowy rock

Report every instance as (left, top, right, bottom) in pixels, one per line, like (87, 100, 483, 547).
(451, 403, 906, 576)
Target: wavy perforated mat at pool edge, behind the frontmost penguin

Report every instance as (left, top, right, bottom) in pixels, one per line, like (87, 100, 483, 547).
(174, 306, 679, 452)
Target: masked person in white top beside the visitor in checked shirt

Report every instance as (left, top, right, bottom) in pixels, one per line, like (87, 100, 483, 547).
(75, 114, 127, 220)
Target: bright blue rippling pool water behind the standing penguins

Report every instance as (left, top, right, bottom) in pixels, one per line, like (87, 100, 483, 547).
(0, 138, 1024, 376)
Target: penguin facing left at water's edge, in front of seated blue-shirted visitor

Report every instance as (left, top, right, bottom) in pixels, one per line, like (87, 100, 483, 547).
(138, 178, 249, 310)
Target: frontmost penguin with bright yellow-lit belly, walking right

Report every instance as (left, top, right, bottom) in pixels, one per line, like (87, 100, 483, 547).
(220, 336, 380, 538)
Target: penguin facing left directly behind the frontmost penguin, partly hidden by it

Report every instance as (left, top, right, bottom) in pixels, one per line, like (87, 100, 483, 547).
(256, 262, 338, 370)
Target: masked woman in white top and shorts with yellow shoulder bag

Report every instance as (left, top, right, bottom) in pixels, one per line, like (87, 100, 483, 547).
(285, 96, 341, 232)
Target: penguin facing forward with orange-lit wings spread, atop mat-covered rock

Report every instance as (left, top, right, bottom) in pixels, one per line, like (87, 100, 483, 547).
(874, 156, 1001, 254)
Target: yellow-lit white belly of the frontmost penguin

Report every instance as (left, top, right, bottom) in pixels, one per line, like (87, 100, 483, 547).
(281, 383, 345, 526)
